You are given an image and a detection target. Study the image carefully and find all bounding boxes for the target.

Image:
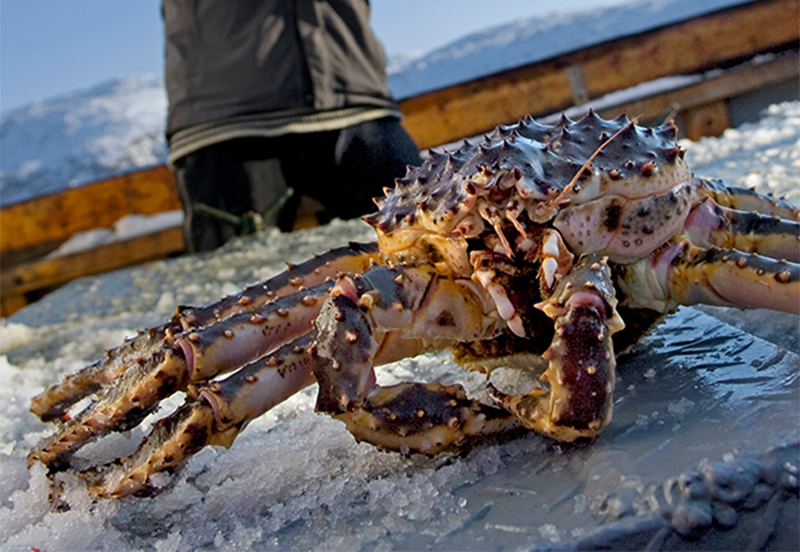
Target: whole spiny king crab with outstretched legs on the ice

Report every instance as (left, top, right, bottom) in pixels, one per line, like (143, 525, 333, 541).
(29, 112, 800, 497)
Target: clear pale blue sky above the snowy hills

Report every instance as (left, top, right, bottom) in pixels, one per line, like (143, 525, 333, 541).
(0, 0, 625, 111)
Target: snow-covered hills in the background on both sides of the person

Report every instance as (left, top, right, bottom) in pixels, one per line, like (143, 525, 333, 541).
(0, 0, 751, 205)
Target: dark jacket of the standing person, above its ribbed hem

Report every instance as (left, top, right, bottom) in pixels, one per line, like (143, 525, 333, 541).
(162, 0, 396, 136)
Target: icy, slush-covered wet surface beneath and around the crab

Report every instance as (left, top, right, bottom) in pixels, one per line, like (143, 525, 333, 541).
(0, 102, 800, 551)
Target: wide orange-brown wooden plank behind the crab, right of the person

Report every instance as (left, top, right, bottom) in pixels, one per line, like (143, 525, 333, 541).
(400, 0, 800, 148)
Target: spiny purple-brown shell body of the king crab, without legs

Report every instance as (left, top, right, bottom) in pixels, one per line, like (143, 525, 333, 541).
(365, 112, 692, 276)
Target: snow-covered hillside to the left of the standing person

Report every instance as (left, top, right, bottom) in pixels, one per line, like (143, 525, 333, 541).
(0, 75, 167, 205)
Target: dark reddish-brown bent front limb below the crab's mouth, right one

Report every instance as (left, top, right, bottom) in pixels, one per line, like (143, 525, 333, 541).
(490, 256, 624, 441)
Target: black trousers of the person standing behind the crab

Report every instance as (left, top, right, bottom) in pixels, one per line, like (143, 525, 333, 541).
(175, 118, 421, 252)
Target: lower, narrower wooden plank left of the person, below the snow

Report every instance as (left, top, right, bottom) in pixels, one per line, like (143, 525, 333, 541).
(0, 227, 183, 302)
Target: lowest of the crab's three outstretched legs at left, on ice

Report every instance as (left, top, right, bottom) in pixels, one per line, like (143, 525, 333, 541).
(81, 332, 315, 498)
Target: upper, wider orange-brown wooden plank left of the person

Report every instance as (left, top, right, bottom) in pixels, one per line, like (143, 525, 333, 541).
(0, 165, 181, 252)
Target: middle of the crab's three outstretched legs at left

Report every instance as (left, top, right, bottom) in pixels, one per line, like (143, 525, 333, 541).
(28, 280, 334, 469)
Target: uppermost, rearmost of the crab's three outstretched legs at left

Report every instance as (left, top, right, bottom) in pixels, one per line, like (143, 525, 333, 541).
(31, 243, 377, 422)
